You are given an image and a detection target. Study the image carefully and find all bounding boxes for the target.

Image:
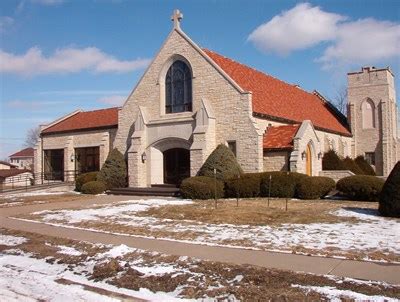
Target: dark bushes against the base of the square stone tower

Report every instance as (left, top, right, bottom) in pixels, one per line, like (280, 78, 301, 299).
(322, 150, 376, 175)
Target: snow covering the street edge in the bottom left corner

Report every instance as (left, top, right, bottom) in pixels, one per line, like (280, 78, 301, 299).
(0, 254, 189, 302)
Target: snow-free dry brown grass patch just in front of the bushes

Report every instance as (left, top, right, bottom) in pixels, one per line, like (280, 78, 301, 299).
(138, 199, 378, 225)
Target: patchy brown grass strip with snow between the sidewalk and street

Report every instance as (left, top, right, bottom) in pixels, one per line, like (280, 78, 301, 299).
(0, 229, 400, 301)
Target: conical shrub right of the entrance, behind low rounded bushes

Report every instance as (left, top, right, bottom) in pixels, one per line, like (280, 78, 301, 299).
(197, 144, 243, 180)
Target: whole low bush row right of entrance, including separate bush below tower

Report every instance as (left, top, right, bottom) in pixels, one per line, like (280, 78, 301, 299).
(181, 172, 384, 201)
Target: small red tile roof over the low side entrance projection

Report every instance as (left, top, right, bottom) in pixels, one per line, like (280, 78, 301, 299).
(263, 125, 300, 150)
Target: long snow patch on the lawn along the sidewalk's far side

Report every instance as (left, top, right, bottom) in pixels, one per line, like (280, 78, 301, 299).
(28, 199, 400, 257)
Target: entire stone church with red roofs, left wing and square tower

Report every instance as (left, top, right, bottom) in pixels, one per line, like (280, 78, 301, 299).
(35, 11, 400, 187)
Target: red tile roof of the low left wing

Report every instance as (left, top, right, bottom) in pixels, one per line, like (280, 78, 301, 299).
(42, 107, 119, 134)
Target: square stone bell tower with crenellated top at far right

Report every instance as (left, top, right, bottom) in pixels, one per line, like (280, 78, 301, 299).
(347, 67, 400, 176)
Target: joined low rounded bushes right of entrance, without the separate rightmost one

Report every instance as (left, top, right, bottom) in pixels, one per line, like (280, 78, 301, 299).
(181, 172, 335, 199)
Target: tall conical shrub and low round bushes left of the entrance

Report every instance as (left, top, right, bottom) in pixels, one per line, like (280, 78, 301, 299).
(75, 149, 127, 194)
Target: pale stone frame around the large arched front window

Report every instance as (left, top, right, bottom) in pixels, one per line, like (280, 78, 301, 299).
(157, 54, 196, 117)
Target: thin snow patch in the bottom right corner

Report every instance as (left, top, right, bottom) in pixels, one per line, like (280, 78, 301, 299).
(292, 284, 399, 302)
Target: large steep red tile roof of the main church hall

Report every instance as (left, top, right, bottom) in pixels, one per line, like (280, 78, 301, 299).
(203, 49, 351, 136)
